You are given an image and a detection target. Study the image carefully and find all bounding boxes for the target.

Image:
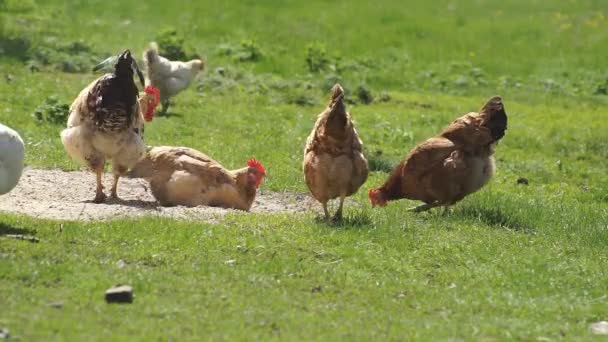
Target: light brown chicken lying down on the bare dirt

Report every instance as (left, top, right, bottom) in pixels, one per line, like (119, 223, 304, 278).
(130, 146, 266, 211)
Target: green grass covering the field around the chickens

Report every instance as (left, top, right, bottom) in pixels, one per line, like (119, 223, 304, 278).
(0, 0, 608, 341)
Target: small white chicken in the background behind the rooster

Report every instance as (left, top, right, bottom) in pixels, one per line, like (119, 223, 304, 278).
(143, 42, 205, 113)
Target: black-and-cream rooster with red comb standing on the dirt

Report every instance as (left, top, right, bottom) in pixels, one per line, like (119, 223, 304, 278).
(61, 50, 159, 203)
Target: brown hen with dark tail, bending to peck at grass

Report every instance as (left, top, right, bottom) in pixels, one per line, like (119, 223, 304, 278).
(369, 96, 507, 212)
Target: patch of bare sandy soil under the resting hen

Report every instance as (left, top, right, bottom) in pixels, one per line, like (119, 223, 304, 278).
(0, 168, 319, 222)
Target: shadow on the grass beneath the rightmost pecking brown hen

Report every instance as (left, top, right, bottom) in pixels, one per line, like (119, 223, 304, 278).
(453, 206, 535, 234)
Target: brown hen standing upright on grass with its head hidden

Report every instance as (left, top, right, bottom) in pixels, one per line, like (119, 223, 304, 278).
(303, 84, 368, 221)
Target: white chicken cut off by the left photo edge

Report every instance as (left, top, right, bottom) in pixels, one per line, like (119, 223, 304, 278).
(0, 124, 25, 195)
